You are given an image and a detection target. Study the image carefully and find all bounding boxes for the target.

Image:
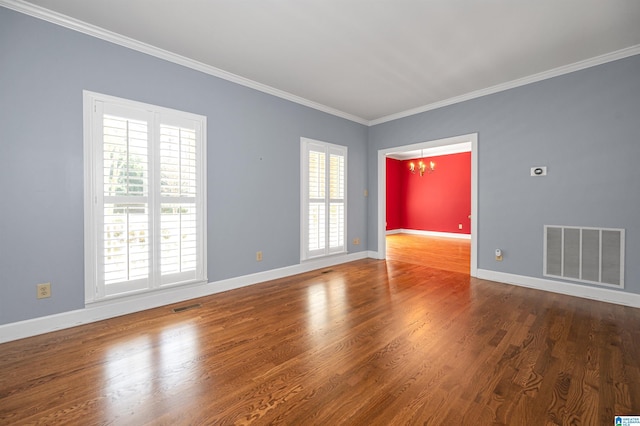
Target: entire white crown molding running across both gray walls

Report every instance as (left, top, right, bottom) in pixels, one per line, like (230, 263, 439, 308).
(0, 0, 640, 126)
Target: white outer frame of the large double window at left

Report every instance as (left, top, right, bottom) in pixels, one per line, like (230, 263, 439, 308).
(83, 90, 208, 304)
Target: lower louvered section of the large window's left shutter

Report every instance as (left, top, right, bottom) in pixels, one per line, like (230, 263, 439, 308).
(103, 204, 149, 285)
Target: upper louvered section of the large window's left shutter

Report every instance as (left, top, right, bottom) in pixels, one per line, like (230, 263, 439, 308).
(103, 115, 149, 196)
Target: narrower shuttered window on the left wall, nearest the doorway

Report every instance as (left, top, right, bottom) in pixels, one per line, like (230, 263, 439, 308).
(301, 138, 347, 260)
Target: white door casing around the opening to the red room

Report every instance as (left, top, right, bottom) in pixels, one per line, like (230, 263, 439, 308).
(376, 133, 478, 277)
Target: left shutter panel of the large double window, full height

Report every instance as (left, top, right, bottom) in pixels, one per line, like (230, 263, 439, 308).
(99, 103, 153, 297)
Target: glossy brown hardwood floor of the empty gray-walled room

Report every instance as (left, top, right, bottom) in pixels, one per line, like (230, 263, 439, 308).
(0, 235, 640, 425)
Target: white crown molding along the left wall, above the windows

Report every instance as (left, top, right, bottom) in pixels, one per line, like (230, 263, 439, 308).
(0, 0, 369, 126)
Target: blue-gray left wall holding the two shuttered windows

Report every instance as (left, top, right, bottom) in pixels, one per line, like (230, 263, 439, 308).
(0, 8, 367, 324)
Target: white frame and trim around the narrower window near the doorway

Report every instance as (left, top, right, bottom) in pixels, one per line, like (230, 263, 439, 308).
(300, 138, 348, 261)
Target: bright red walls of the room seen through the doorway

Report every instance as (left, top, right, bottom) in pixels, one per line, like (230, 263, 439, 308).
(387, 152, 471, 234)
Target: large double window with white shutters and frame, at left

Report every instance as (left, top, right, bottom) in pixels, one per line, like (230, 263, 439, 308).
(84, 91, 206, 302)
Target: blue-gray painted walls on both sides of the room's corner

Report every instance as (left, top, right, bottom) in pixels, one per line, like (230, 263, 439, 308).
(0, 8, 640, 324)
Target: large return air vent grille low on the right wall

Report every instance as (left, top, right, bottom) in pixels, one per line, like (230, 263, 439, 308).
(544, 225, 624, 288)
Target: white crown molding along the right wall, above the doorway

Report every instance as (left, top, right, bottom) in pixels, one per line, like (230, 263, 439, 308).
(368, 45, 640, 126)
